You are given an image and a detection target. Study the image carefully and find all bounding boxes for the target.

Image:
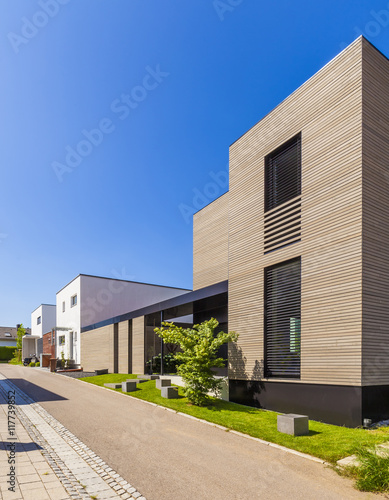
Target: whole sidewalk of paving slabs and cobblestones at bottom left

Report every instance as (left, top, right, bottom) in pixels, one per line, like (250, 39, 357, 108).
(0, 374, 146, 500)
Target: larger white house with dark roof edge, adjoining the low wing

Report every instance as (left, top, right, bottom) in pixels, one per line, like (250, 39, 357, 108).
(55, 274, 188, 364)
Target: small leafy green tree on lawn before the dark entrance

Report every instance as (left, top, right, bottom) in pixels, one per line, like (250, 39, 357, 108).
(154, 318, 238, 406)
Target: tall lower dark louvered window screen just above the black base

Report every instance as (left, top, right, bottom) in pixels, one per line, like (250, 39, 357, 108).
(265, 258, 301, 378)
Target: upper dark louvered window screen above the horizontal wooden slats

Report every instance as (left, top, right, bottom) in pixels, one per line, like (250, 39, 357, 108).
(265, 134, 301, 211)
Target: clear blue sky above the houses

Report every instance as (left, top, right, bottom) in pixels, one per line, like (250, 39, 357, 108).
(0, 0, 389, 326)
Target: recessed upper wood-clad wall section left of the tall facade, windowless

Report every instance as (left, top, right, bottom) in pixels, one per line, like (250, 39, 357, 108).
(193, 193, 228, 290)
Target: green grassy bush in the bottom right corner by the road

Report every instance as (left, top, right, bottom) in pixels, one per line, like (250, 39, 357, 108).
(356, 449, 389, 493)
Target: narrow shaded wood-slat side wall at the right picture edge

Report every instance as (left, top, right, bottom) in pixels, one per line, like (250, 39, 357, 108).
(362, 40, 389, 385)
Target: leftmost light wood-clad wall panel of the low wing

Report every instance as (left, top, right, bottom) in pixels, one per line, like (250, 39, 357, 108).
(81, 325, 114, 373)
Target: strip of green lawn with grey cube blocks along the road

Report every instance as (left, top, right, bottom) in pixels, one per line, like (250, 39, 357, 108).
(80, 374, 389, 464)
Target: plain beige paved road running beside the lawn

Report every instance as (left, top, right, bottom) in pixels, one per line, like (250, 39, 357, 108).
(0, 364, 378, 500)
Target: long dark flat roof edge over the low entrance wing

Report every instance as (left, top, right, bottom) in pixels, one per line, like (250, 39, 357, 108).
(81, 280, 228, 333)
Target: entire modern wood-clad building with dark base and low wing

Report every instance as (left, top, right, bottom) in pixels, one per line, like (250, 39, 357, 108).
(79, 37, 389, 426)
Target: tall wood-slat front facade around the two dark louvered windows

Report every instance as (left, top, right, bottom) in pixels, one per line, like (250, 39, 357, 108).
(228, 39, 362, 385)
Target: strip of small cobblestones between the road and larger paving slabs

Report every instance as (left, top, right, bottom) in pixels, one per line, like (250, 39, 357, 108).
(0, 374, 146, 500)
